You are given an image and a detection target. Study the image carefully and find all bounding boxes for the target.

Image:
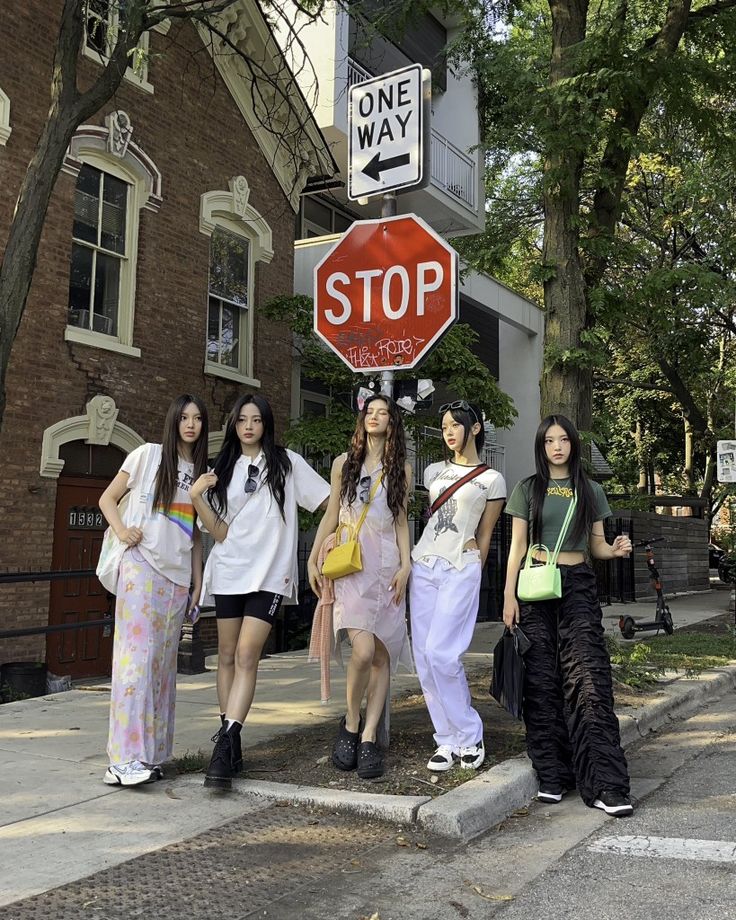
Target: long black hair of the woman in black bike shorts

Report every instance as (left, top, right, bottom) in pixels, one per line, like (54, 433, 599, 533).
(207, 393, 291, 521)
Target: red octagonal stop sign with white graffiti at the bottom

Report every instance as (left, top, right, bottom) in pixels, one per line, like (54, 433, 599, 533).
(314, 214, 457, 372)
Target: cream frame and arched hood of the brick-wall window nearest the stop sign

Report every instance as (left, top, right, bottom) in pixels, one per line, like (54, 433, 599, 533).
(199, 176, 273, 387)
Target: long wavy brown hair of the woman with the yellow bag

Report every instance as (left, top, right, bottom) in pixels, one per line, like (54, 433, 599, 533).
(340, 393, 406, 520)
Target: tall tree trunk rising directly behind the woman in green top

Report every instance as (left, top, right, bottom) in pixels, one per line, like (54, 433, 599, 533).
(541, 0, 593, 430)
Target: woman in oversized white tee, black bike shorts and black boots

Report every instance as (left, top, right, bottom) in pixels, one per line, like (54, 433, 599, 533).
(191, 395, 330, 789)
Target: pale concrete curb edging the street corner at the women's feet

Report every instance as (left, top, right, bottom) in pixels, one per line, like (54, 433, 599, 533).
(204, 665, 736, 842)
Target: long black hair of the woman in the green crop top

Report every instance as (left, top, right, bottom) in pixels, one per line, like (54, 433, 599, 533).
(527, 415, 595, 542)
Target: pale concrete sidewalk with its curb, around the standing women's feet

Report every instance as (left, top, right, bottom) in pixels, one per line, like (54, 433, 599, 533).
(0, 591, 736, 905)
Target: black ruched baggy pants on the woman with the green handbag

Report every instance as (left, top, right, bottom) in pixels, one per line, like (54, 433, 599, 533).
(520, 563, 629, 805)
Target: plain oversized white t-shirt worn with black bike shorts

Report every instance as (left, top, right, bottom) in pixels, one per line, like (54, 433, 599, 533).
(200, 450, 330, 604)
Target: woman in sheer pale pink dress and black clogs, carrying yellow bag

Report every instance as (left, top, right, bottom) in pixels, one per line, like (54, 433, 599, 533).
(308, 395, 412, 779)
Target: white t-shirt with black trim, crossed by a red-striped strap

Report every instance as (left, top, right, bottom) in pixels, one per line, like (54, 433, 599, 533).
(411, 461, 506, 569)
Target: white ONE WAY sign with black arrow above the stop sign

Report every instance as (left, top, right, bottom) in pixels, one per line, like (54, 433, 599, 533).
(348, 64, 431, 201)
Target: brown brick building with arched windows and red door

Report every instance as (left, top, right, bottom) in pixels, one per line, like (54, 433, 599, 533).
(0, 0, 333, 677)
